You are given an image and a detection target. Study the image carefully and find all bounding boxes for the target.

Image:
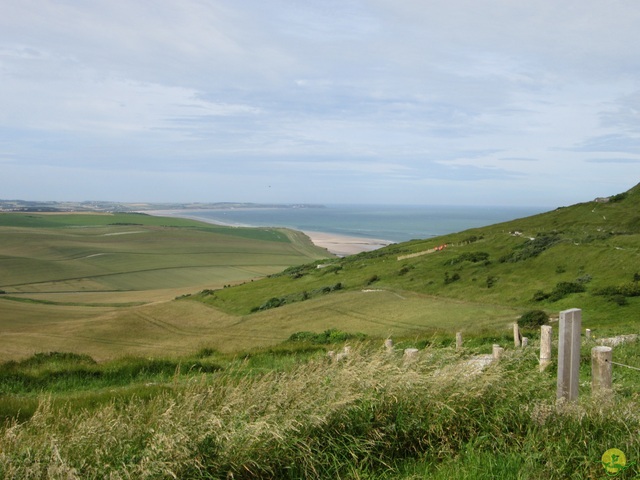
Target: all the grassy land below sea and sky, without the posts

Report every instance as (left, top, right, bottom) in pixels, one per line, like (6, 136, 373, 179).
(0, 187, 640, 479)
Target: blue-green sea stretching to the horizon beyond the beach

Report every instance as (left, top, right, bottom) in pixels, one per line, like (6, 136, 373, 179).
(162, 205, 549, 243)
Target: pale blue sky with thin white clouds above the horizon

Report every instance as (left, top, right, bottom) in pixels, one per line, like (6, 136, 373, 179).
(0, 0, 640, 207)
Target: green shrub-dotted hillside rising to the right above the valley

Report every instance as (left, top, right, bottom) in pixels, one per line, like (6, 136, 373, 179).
(192, 182, 640, 332)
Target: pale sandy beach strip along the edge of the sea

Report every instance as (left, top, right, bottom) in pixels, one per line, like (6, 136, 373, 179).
(146, 210, 394, 257)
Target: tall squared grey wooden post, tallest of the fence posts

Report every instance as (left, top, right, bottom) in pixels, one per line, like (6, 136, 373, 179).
(556, 308, 582, 402)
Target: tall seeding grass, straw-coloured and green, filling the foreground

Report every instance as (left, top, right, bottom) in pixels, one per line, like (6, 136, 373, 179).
(0, 347, 640, 479)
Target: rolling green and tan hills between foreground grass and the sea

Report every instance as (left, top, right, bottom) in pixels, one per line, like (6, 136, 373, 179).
(0, 186, 640, 361)
